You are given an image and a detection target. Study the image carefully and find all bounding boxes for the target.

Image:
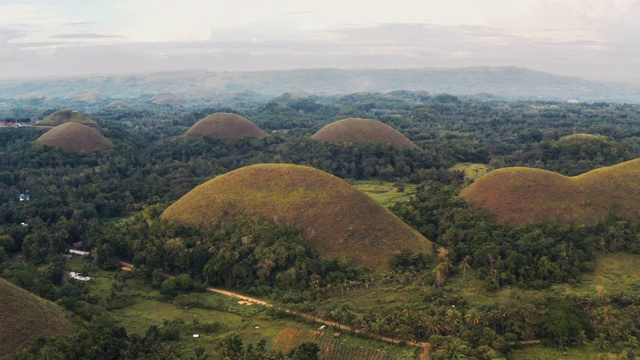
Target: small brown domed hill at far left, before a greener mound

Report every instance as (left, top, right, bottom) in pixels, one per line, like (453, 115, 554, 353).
(36, 123, 113, 152)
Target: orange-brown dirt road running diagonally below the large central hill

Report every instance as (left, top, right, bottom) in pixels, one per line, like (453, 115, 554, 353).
(120, 261, 431, 359)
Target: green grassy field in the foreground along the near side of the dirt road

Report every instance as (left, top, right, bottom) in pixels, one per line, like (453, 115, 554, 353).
(79, 266, 416, 360)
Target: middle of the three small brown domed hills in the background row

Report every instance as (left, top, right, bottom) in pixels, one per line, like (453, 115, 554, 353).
(184, 113, 265, 141)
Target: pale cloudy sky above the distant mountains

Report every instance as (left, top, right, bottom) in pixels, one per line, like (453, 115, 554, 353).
(0, 0, 640, 83)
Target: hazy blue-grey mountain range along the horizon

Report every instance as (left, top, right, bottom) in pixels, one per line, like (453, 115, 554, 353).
(0, 67, 640, 103)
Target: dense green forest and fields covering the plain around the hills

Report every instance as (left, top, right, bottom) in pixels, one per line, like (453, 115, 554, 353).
(0, 91, 640, 359)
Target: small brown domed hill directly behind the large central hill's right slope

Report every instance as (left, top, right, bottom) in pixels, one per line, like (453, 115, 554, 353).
(311, 118, 417, 149)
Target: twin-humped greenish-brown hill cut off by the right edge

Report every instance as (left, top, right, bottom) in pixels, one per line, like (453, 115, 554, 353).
(461, 159, 640, 225)
